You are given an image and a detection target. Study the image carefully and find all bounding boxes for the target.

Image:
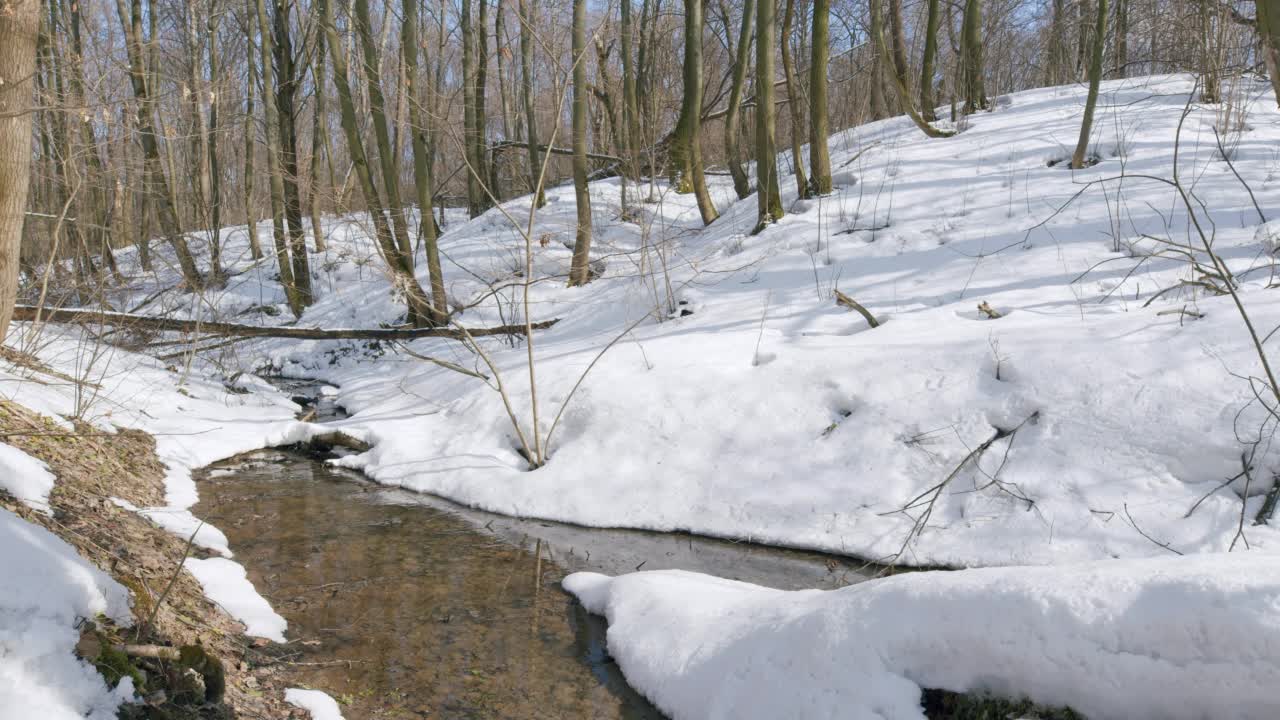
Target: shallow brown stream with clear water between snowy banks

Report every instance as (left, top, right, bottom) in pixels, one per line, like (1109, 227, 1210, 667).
(195, 382, 864, 720)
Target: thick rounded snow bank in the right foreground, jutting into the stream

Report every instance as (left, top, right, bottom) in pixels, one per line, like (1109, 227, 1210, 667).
(563, 553, 1280, 720)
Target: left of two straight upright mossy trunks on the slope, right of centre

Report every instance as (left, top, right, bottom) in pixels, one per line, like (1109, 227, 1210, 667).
(754, 0, 783, 232)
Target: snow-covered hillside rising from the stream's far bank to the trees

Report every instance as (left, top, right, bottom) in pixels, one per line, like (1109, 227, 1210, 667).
(30, 77, 1280, 565)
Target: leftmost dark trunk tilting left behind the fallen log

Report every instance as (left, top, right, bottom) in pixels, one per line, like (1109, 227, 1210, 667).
(115, 0, 204, 291)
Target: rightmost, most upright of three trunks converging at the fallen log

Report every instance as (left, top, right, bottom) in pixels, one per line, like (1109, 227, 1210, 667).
(401, 0, 449, 325)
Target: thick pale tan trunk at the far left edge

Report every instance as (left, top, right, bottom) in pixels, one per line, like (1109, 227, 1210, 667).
(0, 0, 40, 342)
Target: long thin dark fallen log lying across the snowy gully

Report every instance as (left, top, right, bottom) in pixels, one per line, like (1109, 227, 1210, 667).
(13, 299, 559, 341)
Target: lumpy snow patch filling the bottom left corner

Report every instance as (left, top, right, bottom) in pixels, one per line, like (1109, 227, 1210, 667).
(0, 509, 133, 720)
